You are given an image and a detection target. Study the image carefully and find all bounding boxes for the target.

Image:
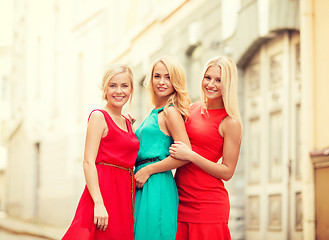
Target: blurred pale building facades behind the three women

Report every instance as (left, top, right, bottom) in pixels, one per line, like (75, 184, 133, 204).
(0, 0, 329, 240)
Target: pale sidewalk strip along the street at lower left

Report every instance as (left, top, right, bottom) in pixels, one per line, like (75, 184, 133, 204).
(0, 214, 66, 240)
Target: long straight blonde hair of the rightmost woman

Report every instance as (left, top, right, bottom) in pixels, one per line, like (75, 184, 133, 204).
(201, 56, 242, 128)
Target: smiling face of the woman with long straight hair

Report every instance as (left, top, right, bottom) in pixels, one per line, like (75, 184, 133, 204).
(202, 66, 222, 101)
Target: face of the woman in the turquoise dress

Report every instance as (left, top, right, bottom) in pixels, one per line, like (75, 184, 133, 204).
(152, 62, 175, 101)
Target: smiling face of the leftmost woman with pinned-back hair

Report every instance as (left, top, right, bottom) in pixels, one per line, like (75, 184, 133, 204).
(106, 72, 132, 108)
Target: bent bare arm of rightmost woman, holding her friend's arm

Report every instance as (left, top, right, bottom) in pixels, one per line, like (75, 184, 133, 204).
(169, 117, 241, 181)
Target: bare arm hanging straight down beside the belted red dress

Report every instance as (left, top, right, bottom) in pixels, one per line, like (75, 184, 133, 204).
(83, 111, 108, 231)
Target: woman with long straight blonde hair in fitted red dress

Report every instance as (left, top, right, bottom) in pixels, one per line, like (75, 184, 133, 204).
(169, 56, 242, 240)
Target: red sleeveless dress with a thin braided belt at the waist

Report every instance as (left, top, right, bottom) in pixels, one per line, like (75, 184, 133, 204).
(62, 109, 139, 240)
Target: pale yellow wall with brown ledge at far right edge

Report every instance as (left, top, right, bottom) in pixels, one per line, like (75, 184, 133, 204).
(300, 0, 329, 240)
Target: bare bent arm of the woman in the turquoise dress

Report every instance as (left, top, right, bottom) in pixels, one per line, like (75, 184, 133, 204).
(135, 107, 191, 187)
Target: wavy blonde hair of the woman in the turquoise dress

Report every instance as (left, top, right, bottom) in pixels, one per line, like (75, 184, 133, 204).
(145, 56, 190, 120)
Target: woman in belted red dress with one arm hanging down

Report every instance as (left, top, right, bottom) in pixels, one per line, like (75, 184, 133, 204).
(62, 64, 139, 240)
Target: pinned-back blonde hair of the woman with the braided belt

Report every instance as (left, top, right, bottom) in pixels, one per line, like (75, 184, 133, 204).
(101, 63, 134, 103)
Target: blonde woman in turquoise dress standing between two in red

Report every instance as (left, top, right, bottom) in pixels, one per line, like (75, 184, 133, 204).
(134, 56, 190, 240)
